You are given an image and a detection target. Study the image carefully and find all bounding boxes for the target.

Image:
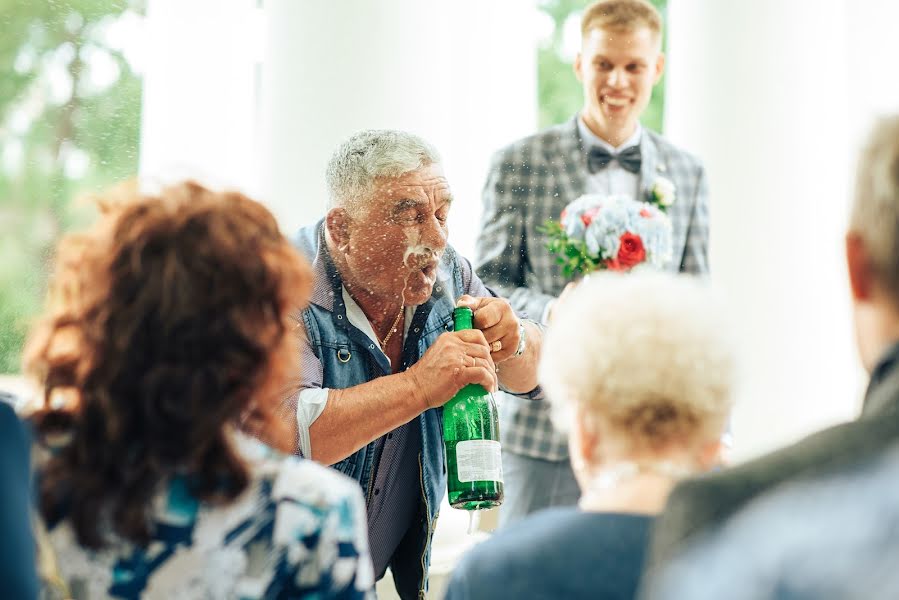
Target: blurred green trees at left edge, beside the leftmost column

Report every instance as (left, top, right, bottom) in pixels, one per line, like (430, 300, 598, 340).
(0, 0, 144, 374)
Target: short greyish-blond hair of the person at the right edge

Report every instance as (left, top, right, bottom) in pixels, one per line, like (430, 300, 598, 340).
(849, 115, 899, 306)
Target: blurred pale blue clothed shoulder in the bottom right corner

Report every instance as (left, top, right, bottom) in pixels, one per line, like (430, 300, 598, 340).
(642, 443, 899, 600)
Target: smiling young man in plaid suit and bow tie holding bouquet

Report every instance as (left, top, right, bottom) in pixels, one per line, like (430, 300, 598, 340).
(476, 0, 709, 523)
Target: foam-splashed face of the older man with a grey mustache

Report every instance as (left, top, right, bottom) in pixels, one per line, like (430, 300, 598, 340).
(329, 164, 452, 306)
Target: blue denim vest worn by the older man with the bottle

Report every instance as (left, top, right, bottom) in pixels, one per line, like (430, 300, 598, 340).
(296, 221, 464, 598)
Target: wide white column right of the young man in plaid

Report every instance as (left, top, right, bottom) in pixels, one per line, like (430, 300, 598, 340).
(665, 0, 860, 458)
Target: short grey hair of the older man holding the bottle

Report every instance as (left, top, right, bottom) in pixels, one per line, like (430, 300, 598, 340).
(325, 129, 440, 211)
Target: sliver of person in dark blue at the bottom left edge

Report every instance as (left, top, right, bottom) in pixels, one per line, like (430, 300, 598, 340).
(0, 390, 38, 600)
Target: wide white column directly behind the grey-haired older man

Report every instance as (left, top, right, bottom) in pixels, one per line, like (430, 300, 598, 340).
(260, 0, 536, 254)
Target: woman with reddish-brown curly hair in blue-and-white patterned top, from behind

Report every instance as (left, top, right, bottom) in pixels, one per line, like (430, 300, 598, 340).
(25, 183, 373, 598)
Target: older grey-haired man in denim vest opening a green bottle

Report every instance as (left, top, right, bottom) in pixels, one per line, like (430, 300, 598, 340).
(278, 130, 542, 598)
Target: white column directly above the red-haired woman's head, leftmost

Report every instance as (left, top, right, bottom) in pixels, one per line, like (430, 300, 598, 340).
(140, 0, 261, 191)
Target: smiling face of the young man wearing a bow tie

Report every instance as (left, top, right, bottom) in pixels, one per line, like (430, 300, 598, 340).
(574, 27, 665, 146)
